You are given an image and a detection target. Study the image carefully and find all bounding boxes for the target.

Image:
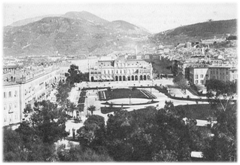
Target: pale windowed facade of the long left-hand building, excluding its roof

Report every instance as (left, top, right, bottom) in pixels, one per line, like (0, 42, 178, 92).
(1, 68, 63, 127)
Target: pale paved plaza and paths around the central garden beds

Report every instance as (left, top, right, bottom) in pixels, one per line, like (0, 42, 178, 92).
(66, 79, 211, 136)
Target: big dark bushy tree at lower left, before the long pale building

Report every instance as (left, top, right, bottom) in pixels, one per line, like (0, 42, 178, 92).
(4, 101, 68, 163)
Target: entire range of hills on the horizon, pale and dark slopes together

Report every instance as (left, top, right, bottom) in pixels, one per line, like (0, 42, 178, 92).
(2, 11, 239, 56)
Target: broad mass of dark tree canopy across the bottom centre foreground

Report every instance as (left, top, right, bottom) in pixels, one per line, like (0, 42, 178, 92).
(78, 102, 204, 163)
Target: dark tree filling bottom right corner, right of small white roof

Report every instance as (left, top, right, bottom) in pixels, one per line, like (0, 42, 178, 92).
(203, 103, 239, 163)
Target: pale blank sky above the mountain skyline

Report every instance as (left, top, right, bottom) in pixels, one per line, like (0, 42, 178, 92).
(1, 0, 239, 33)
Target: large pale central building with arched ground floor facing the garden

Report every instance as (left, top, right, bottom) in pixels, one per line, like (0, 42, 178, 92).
(89, 58, 152, 81)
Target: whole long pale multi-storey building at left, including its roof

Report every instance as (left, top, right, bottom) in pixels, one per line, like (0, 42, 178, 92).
(1, 63, 66, 127)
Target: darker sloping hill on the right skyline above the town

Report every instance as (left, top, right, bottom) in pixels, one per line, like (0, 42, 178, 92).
(151, 19, 239, 45)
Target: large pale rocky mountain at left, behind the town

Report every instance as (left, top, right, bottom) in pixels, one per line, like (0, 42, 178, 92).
(2, 12, 149, 55)
